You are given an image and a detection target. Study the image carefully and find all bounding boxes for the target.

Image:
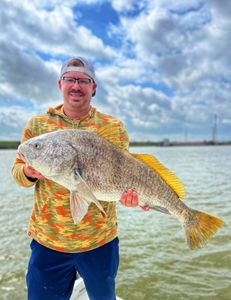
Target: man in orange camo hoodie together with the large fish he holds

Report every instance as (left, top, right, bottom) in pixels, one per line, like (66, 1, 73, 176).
(13, 57, 224, 300)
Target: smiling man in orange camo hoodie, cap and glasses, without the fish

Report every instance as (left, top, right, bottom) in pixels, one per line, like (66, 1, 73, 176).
(12, 57, 148, 300)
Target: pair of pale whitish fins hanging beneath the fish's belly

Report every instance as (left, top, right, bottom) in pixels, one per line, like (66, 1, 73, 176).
(70, 169, 106, 223)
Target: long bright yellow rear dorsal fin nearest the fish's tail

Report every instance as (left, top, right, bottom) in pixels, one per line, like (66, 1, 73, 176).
(130, 153, 185, 199)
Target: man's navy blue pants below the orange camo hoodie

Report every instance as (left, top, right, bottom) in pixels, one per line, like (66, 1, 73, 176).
(26, 238, 119, 300)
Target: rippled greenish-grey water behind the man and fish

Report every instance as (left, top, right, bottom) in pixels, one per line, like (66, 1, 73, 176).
(0, 146, 231, 300)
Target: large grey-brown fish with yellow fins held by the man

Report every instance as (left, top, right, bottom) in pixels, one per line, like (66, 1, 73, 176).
(18, 124, 224, 249)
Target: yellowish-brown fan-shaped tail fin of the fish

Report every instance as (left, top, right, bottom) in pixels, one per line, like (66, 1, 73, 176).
(183, 210, 224, 249)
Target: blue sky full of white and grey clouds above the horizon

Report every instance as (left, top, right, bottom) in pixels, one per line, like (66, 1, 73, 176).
(0, 0, 231, 141)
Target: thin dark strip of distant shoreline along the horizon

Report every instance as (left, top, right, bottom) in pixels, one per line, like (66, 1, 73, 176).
(0, 141, 231, 149)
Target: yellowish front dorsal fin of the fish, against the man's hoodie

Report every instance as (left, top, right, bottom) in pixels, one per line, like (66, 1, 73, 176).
(96, 123, 121, 148)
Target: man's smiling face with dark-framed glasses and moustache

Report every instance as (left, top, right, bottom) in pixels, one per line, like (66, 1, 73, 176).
(58, 71, 96, 113)
